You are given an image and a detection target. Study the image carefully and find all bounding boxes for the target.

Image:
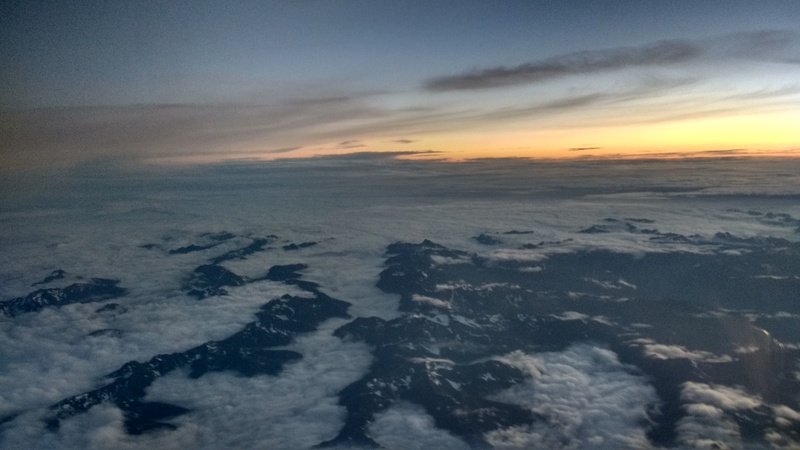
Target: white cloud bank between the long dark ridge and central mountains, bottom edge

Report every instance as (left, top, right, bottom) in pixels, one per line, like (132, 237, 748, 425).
(94, 319, 372, 450)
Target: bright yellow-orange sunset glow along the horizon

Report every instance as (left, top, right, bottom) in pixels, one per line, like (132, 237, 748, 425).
(40, 100, 800, 171)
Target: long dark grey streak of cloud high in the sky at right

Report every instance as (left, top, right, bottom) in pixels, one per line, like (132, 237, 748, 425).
(424, 31, 796, 92)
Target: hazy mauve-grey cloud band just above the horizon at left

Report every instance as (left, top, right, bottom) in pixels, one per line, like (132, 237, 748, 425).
(0, 97, 381, 170)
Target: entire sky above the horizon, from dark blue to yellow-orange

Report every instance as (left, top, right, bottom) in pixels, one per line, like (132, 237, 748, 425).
(0, 0, 800, 170)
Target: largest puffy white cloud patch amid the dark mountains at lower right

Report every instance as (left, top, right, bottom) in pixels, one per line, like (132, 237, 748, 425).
(487, 344, 658, 449)
